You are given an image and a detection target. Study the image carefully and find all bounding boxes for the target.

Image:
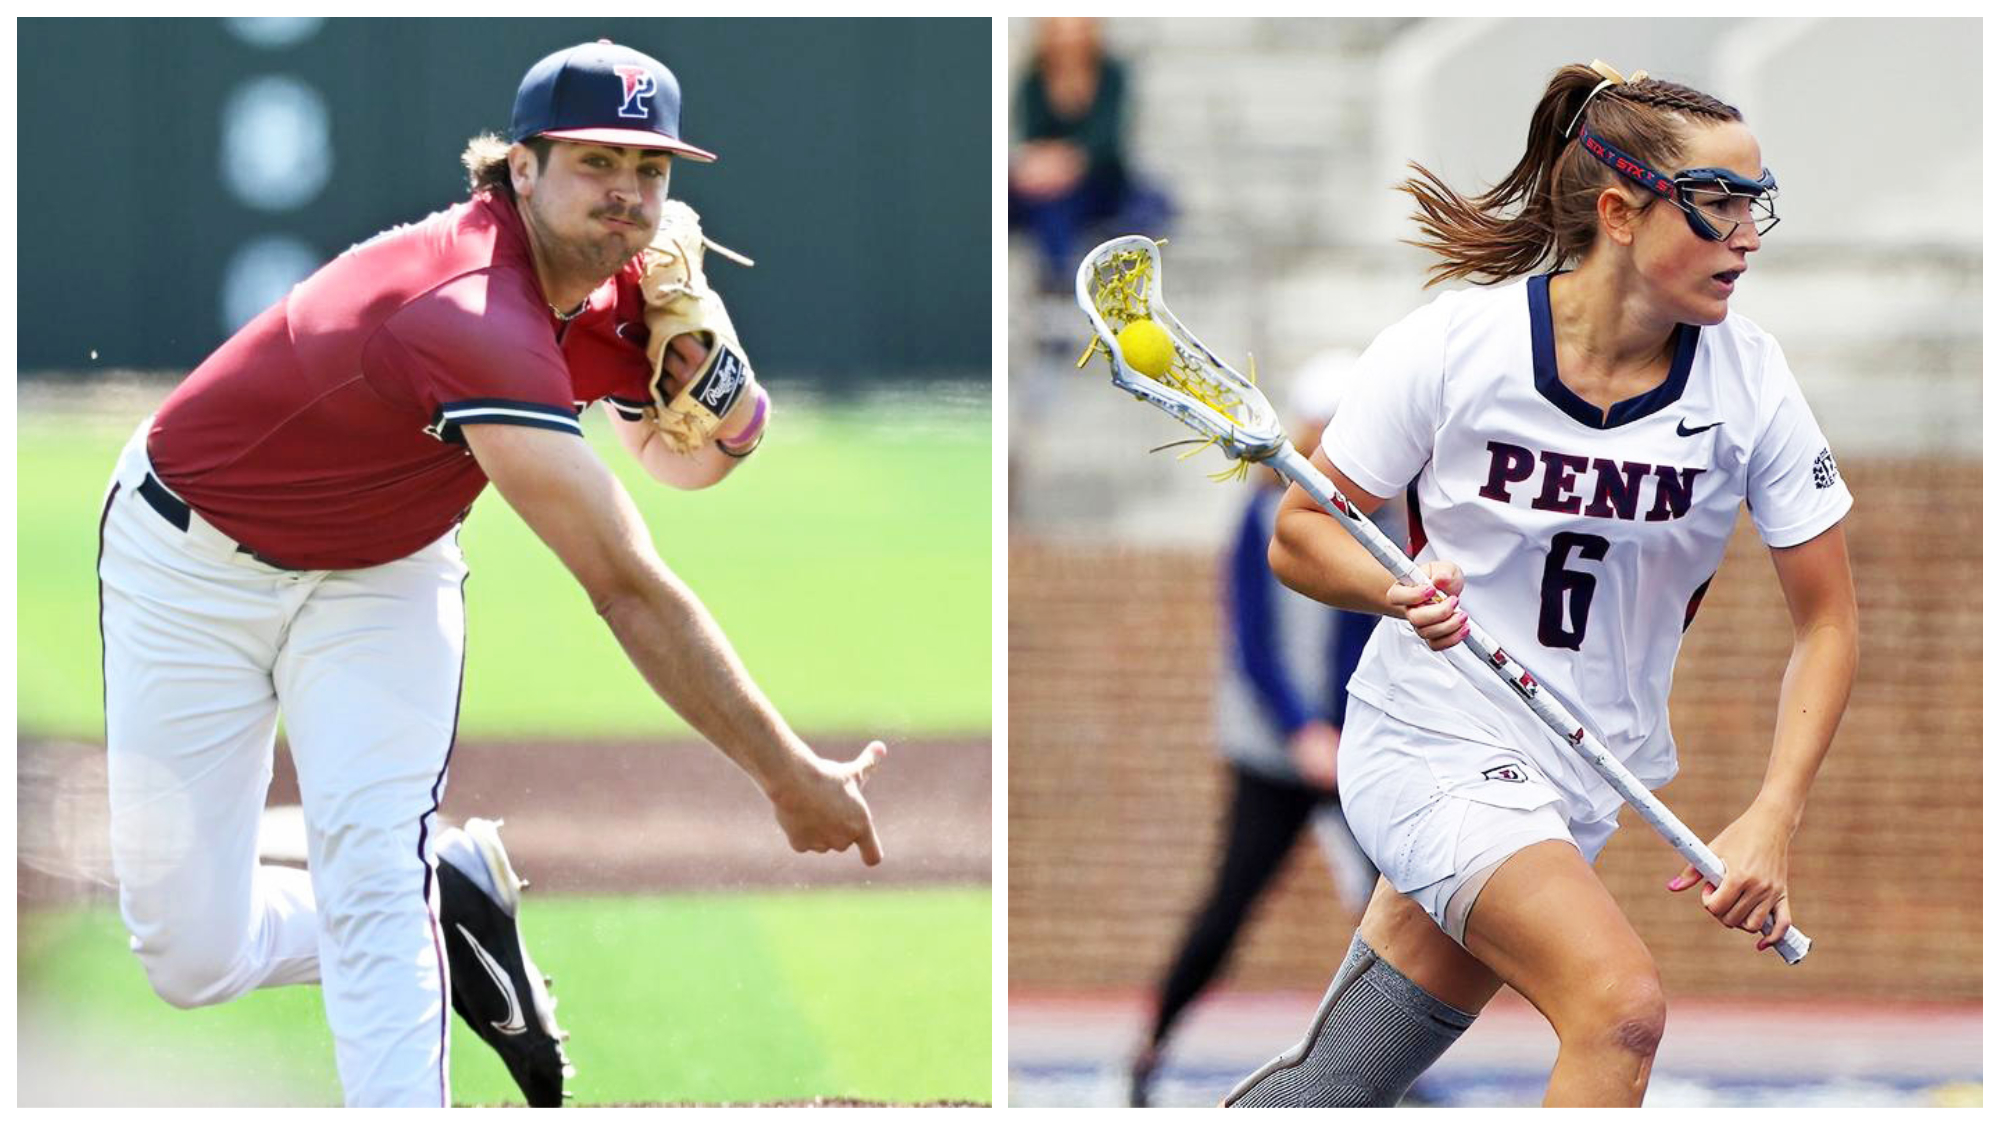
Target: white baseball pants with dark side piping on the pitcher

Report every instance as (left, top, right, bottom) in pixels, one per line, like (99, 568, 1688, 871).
(98, 418, 466, 1107)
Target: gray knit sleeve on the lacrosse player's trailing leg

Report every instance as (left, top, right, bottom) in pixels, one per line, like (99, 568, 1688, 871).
(1222, 933, 1476, 1107)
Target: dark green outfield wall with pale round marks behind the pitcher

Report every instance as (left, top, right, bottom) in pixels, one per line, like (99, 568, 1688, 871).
(16, 18, 992, 390)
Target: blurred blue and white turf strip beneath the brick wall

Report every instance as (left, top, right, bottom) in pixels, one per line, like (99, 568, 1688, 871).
(1008, 991, 1984, 1107)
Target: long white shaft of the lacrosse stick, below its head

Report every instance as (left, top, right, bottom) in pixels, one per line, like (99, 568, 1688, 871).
(1266, 444, 1812, 965)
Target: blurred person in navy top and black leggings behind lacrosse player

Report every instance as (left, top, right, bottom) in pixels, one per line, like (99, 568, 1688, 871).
(1130, 352, 1406, 1105)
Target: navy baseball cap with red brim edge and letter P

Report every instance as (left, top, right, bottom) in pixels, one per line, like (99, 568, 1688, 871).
(508, 40, 716, 162)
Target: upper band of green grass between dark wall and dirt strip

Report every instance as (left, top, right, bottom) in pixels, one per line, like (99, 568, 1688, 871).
(18, 400, 992, 741)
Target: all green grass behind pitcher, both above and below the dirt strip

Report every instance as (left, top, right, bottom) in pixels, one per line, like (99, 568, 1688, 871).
(18, 394, 992, 1105)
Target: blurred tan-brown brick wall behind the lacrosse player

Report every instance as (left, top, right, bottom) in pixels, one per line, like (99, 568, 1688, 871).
(1008, 460, 1982, 999)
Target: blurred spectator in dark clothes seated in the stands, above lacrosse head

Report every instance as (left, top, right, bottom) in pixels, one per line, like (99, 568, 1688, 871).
(1008, 16, 1168, 292)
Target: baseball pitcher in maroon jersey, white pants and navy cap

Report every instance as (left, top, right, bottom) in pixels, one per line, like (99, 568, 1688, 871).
(98, 40, 886, 1107)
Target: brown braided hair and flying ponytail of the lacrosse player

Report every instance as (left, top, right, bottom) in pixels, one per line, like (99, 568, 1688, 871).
(1398, 66, 1742, 286)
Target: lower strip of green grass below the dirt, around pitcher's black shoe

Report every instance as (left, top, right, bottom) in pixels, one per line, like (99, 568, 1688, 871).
(18, 887, 992, 1105)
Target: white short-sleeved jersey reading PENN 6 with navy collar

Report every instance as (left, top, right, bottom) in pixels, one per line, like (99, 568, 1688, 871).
(1324, 276, 1854, 817)
